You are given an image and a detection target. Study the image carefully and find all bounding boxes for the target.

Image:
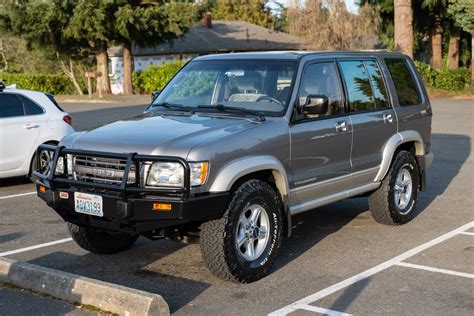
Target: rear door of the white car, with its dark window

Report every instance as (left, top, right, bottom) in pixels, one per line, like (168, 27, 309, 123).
(0, 93, 44, 171)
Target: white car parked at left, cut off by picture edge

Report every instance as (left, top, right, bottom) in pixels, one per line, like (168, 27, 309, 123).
(0, 81, 74, 179)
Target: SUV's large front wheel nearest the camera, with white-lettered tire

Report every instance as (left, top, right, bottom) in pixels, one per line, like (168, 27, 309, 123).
(200, 180, 283, 283)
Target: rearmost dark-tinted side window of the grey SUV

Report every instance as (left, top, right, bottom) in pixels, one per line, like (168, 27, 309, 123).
(385, 58, 421, 106)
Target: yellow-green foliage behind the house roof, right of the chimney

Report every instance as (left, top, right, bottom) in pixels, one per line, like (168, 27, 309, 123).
(205, 0, 276, 29)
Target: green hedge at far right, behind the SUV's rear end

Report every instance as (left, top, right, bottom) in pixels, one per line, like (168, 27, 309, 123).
(415, 61, 471, 92)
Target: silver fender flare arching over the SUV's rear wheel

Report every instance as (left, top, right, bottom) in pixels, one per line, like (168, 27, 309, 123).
(374, 130, 425, 181)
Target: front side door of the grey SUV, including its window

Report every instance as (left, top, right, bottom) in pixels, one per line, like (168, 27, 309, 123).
(289, 61, 352, 206)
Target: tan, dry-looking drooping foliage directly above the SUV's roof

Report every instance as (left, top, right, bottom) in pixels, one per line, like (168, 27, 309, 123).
(287, 0, 380, 50)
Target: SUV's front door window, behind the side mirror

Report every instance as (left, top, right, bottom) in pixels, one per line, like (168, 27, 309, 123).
(298, 62, 343, 118)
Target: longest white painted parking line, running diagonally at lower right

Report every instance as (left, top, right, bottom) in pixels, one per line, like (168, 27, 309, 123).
(269, 221, 474, 316)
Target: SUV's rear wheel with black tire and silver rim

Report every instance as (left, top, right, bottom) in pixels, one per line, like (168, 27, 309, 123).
(369, 151, 420, 225)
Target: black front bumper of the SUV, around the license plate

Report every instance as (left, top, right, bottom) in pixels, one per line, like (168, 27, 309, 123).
(37, 183, 229, 234)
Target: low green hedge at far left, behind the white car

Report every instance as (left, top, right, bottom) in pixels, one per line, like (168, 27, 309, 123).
(0, 73, 75, 94)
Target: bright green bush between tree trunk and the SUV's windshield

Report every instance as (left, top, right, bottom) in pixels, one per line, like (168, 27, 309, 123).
(132, 61, 186, 94)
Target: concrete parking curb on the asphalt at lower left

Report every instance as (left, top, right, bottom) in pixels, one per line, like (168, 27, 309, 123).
(0, 257, 170, 316)
